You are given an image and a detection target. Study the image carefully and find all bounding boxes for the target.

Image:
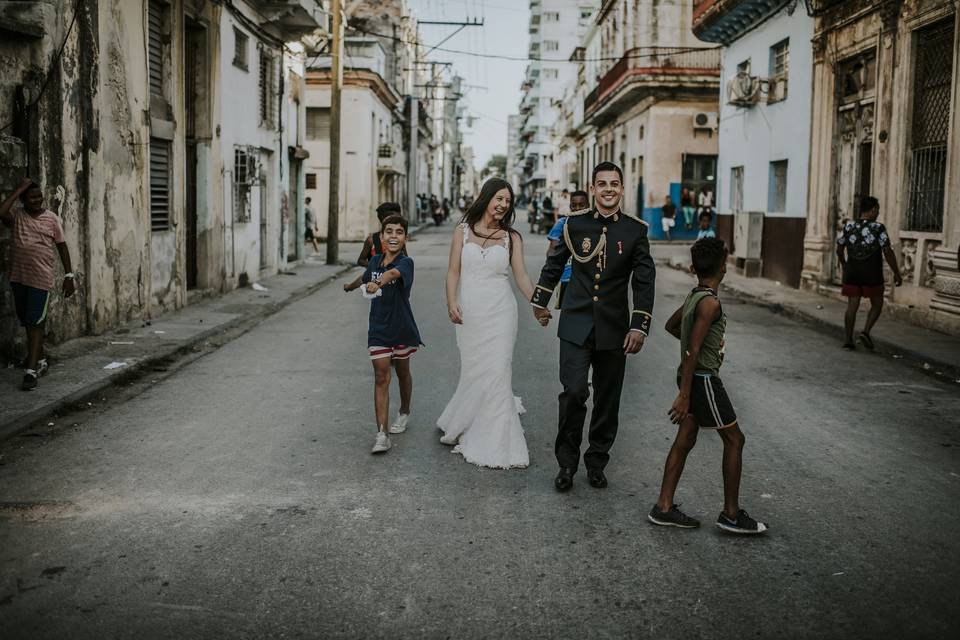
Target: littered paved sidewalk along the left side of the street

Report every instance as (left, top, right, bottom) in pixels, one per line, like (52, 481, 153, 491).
(0, 235, 390, 440)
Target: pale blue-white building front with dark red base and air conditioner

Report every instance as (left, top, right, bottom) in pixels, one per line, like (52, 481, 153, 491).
(693, 0, 813, 287)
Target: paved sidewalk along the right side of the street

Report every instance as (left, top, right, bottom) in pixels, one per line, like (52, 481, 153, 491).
(653, 243, 960, 383)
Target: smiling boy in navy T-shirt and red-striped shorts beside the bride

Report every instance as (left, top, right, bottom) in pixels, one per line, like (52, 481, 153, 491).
(362, 216, 422, 453)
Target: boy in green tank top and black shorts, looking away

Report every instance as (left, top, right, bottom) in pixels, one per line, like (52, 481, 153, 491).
(648, 238, 767, 534)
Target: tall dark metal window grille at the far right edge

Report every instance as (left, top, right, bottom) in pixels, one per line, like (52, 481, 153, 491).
(906, 18, 953, 231)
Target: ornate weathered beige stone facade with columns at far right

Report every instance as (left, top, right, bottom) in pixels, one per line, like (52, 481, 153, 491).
(803, 0, 960, 333)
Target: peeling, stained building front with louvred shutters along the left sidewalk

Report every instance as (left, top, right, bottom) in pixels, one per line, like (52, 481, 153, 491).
(0, 0, 322, 358)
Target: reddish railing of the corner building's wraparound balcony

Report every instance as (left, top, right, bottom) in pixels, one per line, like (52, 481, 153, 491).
(583, 47, 720, 111)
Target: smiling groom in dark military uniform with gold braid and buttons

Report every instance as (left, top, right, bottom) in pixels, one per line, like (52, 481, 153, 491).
(530, 162, 656, 491)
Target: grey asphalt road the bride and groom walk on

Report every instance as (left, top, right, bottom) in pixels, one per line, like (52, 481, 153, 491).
(0, 222, 960, 639)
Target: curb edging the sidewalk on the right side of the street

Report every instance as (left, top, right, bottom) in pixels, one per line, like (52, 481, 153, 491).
(665, 261, 960, 382)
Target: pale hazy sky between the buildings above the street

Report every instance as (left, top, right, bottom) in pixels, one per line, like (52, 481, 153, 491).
(408, 0, 530, 169)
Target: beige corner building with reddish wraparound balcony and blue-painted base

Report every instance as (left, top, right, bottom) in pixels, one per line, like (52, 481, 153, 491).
(571, 0, 720, 238)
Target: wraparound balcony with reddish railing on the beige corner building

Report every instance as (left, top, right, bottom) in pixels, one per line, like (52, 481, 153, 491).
(583, 47, 720, 126)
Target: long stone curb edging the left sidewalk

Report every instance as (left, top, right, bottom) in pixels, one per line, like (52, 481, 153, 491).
(0, 264, 357, 442)
